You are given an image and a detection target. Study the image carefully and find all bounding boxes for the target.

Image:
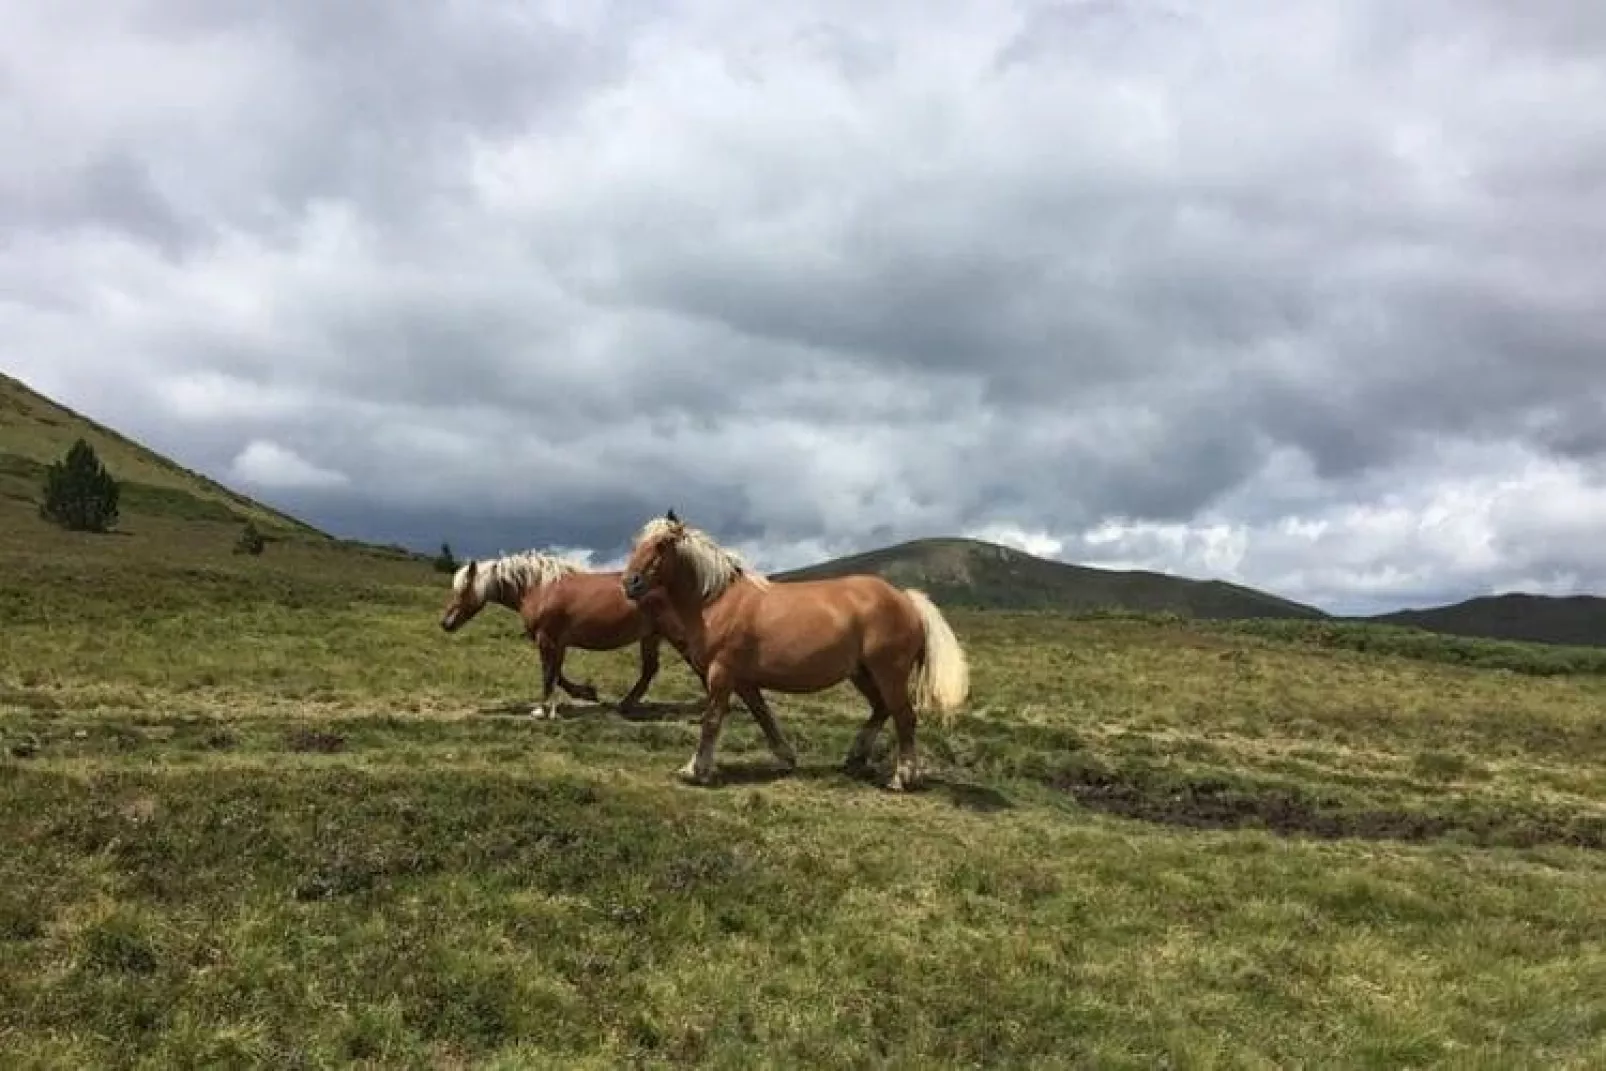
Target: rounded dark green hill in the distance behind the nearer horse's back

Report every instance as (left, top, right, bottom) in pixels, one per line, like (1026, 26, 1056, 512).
(776, 540, 1327, 620)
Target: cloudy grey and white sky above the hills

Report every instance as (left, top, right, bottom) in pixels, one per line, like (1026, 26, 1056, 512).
(0, 0, 1606, 613)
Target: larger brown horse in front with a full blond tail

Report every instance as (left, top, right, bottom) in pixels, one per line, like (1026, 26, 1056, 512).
(622, 509, 970, 792)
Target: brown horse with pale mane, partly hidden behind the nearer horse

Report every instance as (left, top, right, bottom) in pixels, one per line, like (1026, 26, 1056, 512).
(440, 551, 663, 718)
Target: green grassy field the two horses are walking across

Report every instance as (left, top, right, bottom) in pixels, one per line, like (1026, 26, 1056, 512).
(0, 503, 1606, 1068)
